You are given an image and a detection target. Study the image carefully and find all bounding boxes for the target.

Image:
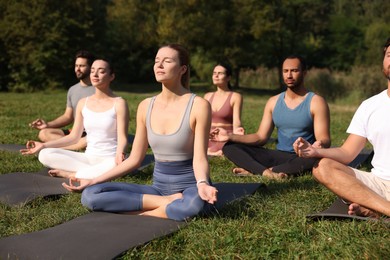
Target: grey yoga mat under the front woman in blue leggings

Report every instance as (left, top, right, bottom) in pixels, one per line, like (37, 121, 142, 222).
(0, 183, 263, 260)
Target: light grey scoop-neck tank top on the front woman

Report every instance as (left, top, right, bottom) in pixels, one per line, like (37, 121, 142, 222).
(146, 94, 196, 161)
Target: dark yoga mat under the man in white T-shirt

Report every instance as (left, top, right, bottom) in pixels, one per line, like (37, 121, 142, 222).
(306, 198, 377, 220)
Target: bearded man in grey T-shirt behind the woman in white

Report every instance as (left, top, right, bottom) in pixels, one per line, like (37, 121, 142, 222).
(29, 50, 95, 150)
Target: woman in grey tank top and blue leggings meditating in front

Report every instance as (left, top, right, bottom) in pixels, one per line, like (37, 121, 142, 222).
(64, 44, 218, 220)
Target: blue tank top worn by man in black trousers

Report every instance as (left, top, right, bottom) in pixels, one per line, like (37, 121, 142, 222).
(272, 92, 315, 152)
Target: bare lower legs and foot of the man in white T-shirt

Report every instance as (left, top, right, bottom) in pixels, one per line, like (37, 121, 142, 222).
(313, 158, 390, 217)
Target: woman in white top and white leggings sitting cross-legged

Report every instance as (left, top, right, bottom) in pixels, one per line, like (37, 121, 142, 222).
(21, 59, 129, 179)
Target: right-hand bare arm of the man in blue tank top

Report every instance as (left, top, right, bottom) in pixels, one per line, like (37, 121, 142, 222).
(310, 95, 331, 148)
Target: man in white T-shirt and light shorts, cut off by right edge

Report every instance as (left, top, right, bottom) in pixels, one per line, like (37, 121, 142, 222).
(294, 38, 390, 217)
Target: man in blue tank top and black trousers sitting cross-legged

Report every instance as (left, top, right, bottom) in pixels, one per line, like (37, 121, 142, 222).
(211, 56, 330, 179)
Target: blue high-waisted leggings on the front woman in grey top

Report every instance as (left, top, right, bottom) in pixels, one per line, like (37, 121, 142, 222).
(81, 160, 205, 221)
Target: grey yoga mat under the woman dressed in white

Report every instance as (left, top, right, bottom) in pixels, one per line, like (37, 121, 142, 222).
(0, 154, 154, 206)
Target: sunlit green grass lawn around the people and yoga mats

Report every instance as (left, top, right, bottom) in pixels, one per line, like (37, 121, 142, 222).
(0, 86, 390, 259)
